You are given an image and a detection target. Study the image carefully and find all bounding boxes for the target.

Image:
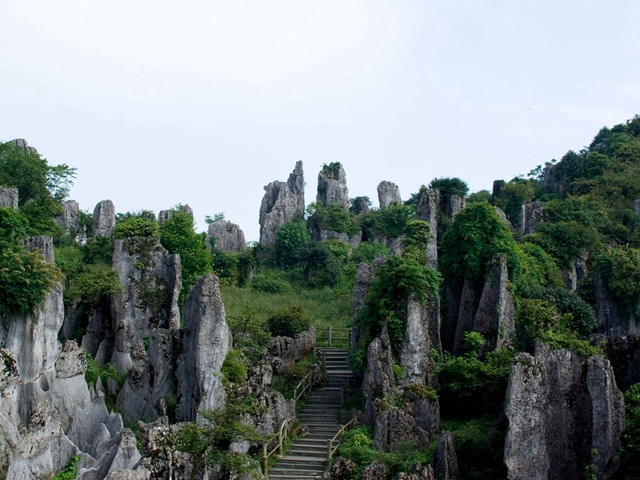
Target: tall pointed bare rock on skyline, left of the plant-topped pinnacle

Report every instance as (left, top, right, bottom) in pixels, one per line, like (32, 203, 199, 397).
(260, 162, 304, 245)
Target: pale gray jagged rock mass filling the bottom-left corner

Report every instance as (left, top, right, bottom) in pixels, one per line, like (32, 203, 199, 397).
(0, 244, 140, 480)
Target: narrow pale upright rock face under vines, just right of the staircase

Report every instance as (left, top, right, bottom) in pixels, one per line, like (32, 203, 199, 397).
(400, 295, 440, 385)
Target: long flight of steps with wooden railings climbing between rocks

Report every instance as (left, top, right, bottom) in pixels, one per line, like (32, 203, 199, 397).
(268, 348, 352, 480)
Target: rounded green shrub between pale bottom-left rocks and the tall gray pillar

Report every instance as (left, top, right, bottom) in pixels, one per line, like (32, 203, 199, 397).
(65, 263, 122, 308)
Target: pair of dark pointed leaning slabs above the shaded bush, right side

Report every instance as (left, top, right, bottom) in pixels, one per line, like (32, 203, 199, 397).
(444, 254, 515, 354)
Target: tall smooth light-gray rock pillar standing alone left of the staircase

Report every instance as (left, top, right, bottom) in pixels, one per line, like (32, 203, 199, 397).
(178, 274, 231, 421)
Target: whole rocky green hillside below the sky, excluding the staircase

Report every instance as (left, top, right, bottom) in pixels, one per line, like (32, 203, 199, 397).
(0, 116, 640, 480)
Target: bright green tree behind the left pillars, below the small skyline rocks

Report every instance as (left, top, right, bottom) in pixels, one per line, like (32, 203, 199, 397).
(160, 210, 211, 295)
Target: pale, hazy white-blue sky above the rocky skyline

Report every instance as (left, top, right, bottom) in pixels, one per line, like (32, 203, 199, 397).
(0, 0, 640, 241)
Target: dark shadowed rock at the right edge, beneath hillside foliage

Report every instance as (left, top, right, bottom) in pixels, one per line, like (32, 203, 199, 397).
(595, 272, 640, 336)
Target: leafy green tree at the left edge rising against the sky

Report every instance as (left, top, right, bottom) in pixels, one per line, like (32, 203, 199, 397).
(0, 142, 75, 235)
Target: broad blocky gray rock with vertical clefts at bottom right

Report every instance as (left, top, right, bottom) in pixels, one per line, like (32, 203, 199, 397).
(504, 345, 624, 480)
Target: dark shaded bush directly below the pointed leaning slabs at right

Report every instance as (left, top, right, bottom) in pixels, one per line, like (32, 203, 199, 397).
(436, 348, 513, 418)
